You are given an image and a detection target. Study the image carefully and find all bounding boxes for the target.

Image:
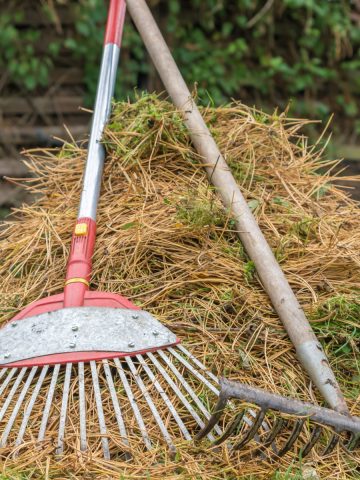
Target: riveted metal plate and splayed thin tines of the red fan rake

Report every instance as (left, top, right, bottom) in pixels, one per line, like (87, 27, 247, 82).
(0, 307, 222, 459)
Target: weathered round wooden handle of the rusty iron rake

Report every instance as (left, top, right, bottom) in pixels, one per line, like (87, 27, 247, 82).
(127, 0, 348, 413)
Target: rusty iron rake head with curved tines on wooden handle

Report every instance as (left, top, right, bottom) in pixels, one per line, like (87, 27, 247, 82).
(197, 379, 360, 457)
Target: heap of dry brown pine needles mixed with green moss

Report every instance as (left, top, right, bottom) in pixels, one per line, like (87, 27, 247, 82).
(0, 95, 360, 479)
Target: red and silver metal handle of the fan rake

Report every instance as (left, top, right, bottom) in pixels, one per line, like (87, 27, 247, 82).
(64, 0, 126, 307)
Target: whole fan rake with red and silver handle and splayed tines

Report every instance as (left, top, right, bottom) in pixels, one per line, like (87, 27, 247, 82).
(0, 0, 357, 459)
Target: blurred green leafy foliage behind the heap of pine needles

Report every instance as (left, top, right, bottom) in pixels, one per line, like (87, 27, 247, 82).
(0, 0, 360, 137)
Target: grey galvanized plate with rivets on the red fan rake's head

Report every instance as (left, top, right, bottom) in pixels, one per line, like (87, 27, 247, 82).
(0, 307, 177, 365)
